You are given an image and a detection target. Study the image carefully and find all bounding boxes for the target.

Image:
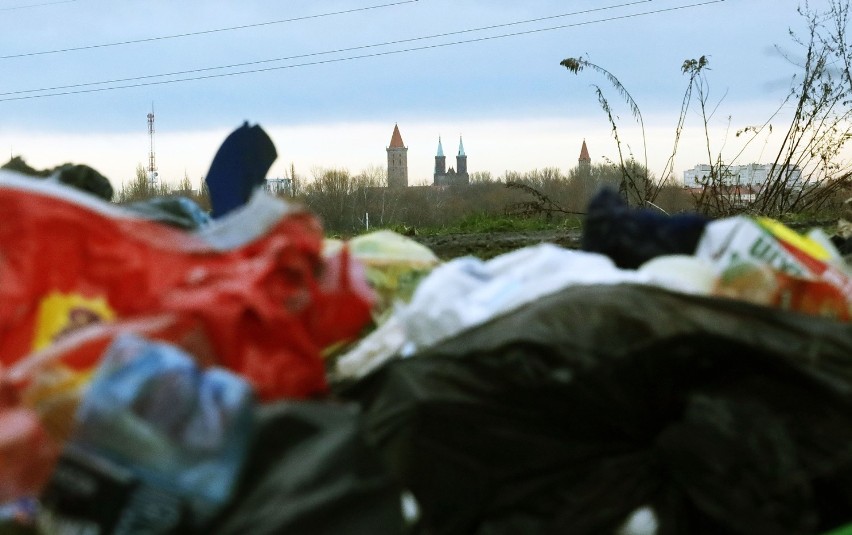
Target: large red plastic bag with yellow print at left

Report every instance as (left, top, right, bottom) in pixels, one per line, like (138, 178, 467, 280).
(0, 173, 371, 399)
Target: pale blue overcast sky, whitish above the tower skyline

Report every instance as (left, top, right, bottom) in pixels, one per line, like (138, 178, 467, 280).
(0, 0, 840, 189)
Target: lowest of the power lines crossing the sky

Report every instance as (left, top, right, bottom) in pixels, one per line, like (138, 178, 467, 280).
(0, 0, 725, 102)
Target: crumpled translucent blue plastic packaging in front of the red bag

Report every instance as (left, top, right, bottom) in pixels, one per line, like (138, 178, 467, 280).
(39, 335, 254, 533)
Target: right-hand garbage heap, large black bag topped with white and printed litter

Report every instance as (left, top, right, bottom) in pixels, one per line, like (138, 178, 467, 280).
(334, 191, 852, 534)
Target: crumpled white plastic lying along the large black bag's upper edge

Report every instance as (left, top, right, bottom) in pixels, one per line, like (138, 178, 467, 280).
(335, 244, 651, 380)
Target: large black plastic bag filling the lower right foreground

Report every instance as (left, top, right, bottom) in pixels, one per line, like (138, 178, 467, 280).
(342, 285, 852, 535)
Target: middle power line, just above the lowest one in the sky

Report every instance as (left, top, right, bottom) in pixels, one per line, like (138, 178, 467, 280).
(0, 0, 654, 96)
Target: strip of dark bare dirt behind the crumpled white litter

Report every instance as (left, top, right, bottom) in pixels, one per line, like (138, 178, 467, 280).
(413, 230, 580, 260)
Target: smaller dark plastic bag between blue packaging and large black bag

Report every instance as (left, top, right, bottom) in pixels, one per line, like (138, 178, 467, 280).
(208, 402, 403, 535)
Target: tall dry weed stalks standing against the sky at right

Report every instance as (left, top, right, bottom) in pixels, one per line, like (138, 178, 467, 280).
(561, 0, 852, 217)
